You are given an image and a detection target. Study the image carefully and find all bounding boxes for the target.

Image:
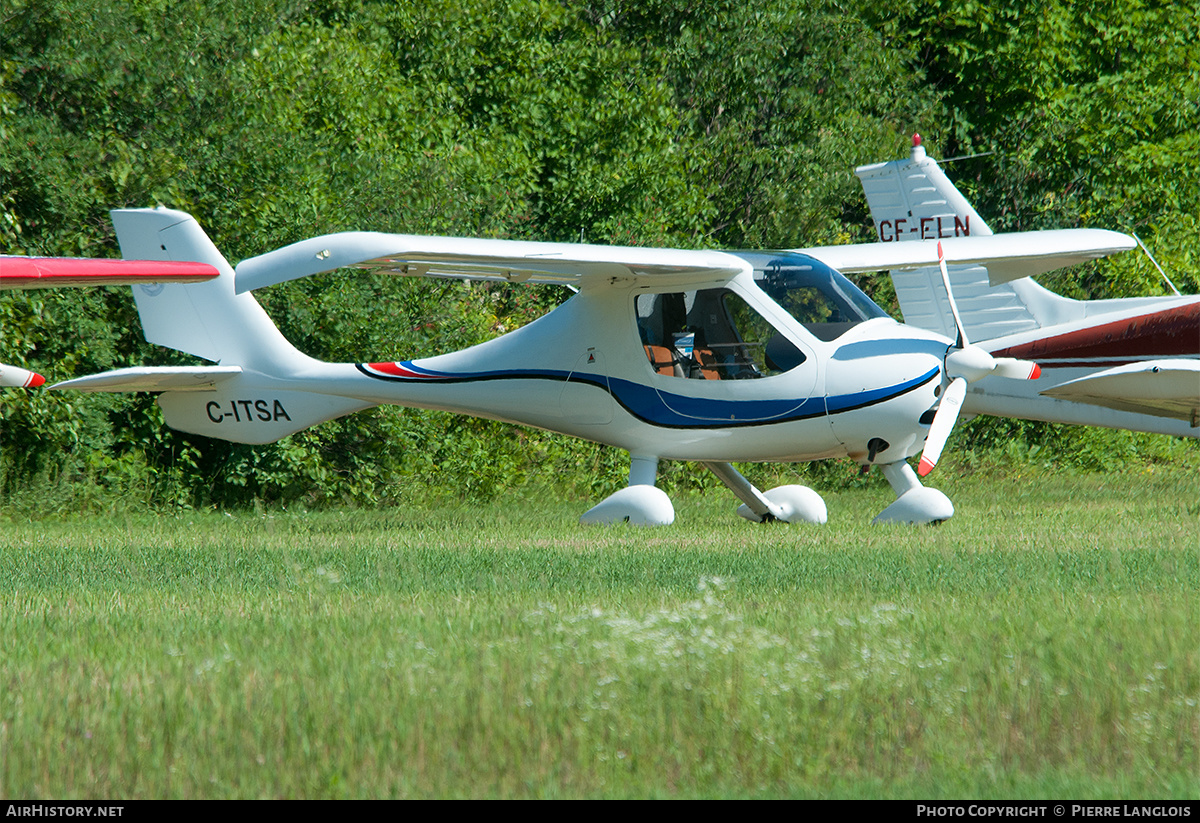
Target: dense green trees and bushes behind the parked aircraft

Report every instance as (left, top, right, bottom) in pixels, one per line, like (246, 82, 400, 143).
(0, 0, 1200, 507)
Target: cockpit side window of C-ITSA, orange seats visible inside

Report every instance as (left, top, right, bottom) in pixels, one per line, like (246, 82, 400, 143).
(635, 288, 805, 380)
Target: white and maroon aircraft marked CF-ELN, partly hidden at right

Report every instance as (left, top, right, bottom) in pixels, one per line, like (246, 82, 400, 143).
(805, 136, 1200, 438)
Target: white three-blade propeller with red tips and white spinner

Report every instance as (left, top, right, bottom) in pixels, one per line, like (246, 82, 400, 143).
(917, 242, 1042, 477)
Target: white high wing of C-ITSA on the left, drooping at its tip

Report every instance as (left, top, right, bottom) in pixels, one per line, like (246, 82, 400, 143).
(234, 232, 748, 294)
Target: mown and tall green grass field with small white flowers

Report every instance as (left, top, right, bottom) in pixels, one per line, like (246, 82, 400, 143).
(0, 468, 1200, 799)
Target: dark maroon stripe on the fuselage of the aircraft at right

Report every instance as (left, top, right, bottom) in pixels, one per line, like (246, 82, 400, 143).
(992, 302, 1200, 366)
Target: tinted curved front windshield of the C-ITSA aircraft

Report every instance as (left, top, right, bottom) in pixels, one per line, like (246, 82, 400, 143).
(734, 252, 888, 342)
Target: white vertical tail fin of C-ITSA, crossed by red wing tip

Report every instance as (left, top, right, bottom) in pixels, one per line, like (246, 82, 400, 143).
(112, 209, 312, 374)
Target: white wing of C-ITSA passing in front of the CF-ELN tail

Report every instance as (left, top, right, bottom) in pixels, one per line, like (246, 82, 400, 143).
(794, 229, 1138, 286)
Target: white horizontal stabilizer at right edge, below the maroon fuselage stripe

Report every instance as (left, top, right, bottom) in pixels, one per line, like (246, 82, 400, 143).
(1042, 360, 1200, 427)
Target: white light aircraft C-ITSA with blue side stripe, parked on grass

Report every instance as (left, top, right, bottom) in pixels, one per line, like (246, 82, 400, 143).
(44, 209, 1122, 524)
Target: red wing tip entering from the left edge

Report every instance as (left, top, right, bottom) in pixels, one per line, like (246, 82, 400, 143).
(0, 254, 218, 289)
